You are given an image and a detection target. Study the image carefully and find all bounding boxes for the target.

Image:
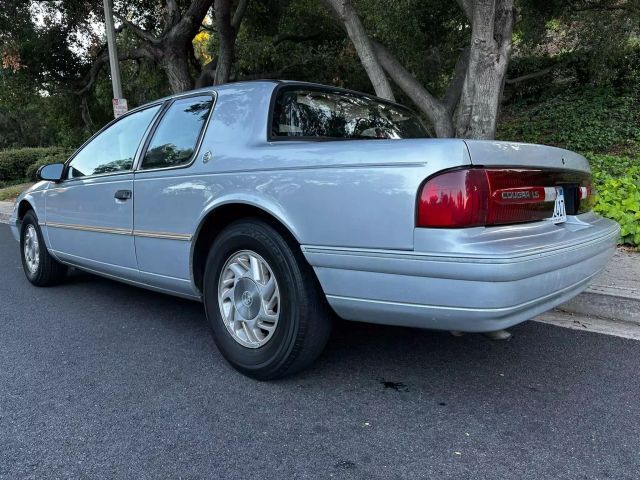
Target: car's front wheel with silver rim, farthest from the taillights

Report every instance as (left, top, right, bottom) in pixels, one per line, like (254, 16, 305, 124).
(20, 211, 67, 287)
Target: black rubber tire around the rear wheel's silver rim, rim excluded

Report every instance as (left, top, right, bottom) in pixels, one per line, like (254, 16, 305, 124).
(203, 219, 331, 380)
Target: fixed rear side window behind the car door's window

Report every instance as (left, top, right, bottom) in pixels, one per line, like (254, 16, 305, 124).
(140, 95, 213, 170)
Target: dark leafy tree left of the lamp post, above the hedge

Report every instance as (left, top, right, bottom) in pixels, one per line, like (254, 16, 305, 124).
(0, 0, 100, 146)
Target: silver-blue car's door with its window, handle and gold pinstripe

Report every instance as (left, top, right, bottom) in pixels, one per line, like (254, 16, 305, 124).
(45, 104, 161, 279)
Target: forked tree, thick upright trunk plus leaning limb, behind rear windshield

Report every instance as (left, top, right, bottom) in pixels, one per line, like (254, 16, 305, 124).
(325, 0, 515, 138)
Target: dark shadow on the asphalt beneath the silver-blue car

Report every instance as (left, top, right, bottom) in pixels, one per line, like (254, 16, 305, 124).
(62, 271, 608, 404)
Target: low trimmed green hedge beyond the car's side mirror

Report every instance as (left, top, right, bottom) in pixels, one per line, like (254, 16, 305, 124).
(0, 147, 70, 182)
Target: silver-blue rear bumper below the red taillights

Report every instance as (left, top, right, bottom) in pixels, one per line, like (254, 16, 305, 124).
(303, 214, 619, 332)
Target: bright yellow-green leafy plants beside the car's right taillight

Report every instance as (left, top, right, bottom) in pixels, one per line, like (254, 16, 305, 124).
(594, 166, 640, 247)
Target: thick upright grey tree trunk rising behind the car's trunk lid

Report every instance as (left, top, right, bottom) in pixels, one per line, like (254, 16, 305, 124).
(456, 0, 515, 139)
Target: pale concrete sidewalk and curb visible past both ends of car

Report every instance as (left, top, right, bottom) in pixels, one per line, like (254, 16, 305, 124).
(0, 197, 640, 325)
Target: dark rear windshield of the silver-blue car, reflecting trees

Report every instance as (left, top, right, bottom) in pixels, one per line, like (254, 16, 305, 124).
(271, 88, 429, 140)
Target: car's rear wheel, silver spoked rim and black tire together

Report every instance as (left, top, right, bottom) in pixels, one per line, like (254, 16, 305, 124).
(203, 219, 331, 380)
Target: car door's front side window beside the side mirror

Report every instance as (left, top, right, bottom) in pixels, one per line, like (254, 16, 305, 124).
(67, 105, 160, 178)
